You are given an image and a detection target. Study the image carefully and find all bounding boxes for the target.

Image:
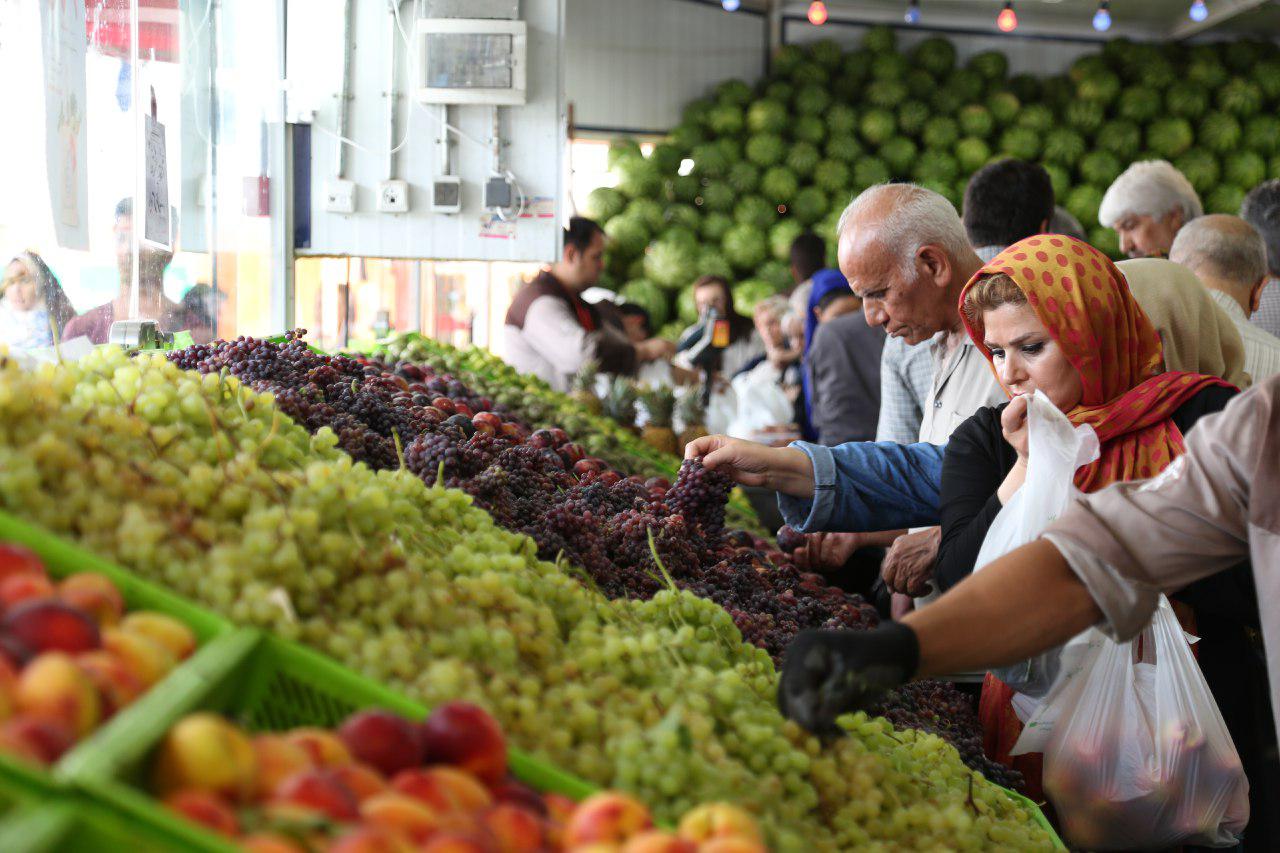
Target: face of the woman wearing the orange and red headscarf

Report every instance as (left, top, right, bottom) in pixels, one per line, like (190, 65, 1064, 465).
(982, 305, 1083, 412)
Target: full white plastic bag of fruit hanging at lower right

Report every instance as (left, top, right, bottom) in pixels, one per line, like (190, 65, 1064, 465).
(1029, 597, 1249, 850)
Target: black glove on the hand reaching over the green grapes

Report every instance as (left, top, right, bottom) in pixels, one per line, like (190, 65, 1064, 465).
(778, 622, 920, 735)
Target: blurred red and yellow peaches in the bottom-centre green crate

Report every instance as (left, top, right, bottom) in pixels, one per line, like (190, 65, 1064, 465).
(151, 702, 765, 853)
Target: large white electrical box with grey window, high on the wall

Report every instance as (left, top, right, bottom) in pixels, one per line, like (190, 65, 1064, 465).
(413, 18, 529, 106)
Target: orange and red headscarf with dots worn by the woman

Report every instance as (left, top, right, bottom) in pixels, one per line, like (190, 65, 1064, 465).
(960, 234, 1230, 492)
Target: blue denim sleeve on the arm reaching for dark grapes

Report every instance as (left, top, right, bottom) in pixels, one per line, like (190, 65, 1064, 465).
(778, 442, 945, 533)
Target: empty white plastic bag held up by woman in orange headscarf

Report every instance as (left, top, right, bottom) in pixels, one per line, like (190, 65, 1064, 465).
(974, 391, 1098, 698)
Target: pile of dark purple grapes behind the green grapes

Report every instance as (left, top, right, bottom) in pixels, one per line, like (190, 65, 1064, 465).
(169, 330, 877, 660)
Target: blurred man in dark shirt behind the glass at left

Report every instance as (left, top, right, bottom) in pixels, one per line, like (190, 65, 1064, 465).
(63, 199, 191, 343)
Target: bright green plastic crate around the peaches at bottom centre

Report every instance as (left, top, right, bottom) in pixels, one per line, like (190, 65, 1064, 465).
(64, 629, 595, 852)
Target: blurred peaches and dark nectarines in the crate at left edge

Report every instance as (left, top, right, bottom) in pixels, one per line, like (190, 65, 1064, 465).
(0, 544, 196, 765)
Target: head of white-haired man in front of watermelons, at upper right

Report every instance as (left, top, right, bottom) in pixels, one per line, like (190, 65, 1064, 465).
(1098, 160, 1204, 257)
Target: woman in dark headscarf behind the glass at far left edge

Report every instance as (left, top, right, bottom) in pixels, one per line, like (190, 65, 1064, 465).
(0, 252, 76, 350)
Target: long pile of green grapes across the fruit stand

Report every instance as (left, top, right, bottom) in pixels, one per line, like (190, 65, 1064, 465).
(0, 348, 1051, 850)
